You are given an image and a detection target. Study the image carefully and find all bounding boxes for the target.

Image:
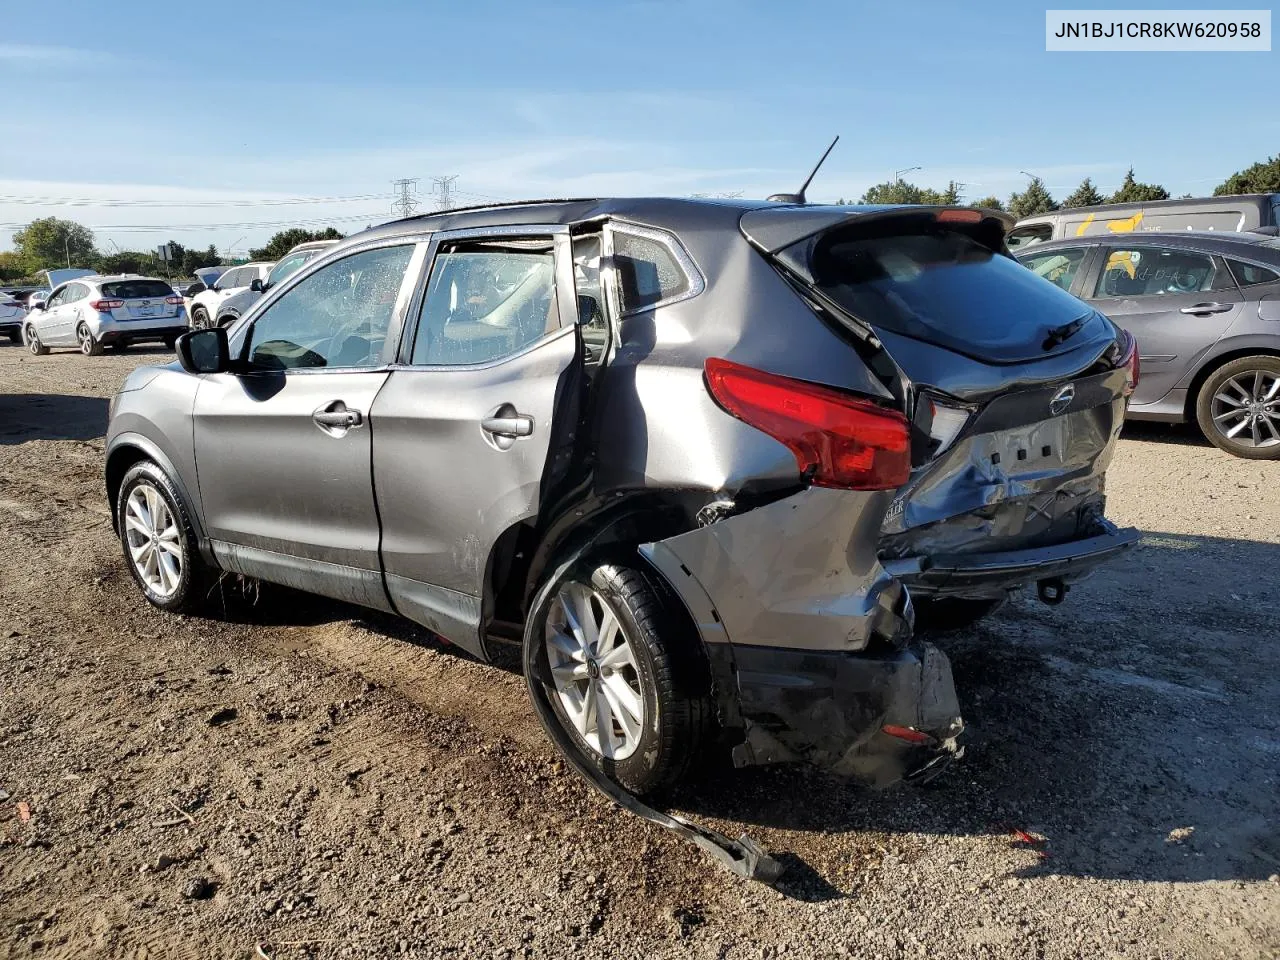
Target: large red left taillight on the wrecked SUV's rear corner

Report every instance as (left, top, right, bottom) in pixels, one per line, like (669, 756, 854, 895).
(705, 357, 911, 490)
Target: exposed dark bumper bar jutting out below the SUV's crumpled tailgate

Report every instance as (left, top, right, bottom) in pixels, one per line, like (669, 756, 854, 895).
(883, 520, 1142, 596)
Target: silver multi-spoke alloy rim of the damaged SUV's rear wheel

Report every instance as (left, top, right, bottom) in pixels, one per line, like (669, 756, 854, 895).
(547, 582, 645, 760)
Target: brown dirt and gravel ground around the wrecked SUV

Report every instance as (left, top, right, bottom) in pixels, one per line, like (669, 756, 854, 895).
(0, 344, 1280, 960)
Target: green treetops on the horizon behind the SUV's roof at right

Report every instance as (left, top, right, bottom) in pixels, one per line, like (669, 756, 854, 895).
(840, 155, 1280, 220)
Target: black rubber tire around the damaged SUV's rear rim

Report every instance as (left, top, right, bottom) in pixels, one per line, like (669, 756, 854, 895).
(534, 563, 714, 796)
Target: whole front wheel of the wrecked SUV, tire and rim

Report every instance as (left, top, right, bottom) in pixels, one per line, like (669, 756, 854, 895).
(116, 461, 211, 613)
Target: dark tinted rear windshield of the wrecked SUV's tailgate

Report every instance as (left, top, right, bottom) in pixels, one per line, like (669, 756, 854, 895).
(785, 228, 1093, 362)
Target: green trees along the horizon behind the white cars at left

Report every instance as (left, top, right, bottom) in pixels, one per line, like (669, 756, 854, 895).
(0, 216, 343, 283)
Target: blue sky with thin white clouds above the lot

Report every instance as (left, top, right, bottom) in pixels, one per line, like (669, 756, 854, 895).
(0, 0, 1280, 257)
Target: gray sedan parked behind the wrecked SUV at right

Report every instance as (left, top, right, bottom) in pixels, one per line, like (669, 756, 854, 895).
(1018, 230, 1280, 460)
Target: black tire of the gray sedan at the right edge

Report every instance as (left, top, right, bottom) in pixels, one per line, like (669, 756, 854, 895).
(1196, 355, 1280, 460)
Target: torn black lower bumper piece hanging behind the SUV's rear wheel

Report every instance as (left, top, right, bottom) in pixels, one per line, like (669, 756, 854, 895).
(733, 644, 964, 786)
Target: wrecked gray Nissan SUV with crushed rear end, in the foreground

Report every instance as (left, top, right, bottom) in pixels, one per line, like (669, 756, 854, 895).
(106, 200, 1138, 794)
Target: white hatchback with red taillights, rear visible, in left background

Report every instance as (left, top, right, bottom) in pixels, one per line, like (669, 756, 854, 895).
(22, 274, 187, 357)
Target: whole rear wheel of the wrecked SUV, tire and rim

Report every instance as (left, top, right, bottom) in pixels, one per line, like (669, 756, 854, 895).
(534, 564, 712, 795)
